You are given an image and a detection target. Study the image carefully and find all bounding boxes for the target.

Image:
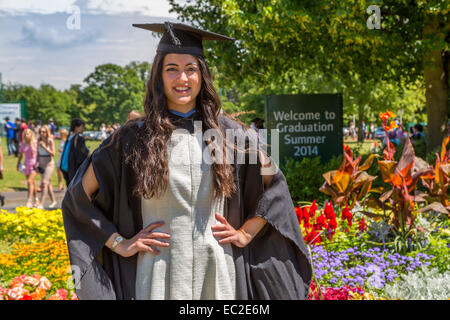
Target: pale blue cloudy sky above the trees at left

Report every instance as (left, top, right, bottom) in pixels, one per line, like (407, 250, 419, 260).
(0, 0, 182, 89)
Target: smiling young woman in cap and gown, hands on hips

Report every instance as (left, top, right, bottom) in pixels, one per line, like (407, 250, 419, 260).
(62, 23, 311, 299)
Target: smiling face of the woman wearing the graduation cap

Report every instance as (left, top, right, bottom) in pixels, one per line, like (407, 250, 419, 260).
(162, 53, 202, 112)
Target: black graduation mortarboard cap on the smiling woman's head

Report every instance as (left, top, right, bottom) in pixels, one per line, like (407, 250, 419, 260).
(133, 22, 235, 57)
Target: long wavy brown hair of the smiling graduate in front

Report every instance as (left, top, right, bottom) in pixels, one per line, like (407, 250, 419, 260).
(111, 53, 236, 199)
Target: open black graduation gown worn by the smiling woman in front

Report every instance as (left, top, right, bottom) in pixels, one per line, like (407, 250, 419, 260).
(62, 116, 312, 300)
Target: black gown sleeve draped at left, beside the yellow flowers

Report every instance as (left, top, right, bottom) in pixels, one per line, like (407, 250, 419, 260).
(61, 134, 120, 299)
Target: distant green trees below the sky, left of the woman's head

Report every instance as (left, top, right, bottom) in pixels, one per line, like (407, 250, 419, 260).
(3, 61, 150, 129)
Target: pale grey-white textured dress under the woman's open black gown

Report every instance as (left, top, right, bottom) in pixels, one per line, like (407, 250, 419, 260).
(136, 126, 236, 300)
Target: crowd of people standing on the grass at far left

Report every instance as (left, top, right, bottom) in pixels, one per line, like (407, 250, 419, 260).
(0, 117, 89, 209)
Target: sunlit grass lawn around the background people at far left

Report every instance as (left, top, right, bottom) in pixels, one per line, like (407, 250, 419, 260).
(0, 137, 100, 191)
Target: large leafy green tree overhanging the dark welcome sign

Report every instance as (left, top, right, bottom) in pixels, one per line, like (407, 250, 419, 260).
(169, 0, 450, 149)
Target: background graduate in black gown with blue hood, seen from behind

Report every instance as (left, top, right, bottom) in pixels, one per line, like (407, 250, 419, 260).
(60, 119, 89, 186)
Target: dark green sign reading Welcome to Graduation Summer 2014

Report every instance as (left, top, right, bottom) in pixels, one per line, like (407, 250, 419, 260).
(265, 94, 343, 163)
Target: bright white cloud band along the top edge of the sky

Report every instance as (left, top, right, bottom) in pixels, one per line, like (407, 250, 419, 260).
(0, 0, 181, 17)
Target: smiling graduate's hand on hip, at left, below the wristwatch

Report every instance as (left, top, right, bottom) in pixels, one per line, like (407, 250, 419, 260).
(114, 221, 170, 258)
